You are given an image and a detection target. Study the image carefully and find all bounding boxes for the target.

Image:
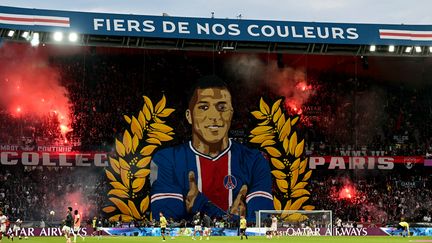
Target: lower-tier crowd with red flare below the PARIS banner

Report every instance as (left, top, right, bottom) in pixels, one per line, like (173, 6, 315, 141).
(310, 168, 432, 226)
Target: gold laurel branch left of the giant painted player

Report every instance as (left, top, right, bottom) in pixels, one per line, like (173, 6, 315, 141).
(102, 95, 175, 221)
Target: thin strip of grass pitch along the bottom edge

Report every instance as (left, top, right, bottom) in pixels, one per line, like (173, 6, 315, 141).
(11, 236, 432, 243)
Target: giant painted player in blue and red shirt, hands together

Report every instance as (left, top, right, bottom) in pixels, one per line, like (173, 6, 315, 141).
(151, 76, 273, 220)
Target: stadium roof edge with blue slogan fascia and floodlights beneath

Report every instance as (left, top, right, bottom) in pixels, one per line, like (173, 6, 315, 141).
(0, 6, 432, 56)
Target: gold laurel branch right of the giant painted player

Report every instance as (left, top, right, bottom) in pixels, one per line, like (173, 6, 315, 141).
(249, 97, 315, 222)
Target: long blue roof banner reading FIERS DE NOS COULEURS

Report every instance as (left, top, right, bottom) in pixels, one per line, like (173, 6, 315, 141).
(0, 6, 432, 45)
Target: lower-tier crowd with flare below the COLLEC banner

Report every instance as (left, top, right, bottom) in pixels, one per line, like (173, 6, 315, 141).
(0, 166, 107, 223)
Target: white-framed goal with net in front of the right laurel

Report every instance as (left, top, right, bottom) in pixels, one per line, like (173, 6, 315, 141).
(256, 210, 333, 236)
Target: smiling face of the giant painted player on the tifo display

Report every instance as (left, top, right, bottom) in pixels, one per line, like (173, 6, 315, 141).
(186, 88, 233, 144)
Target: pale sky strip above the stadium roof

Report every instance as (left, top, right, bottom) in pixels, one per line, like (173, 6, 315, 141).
(0, 0, 432, 25)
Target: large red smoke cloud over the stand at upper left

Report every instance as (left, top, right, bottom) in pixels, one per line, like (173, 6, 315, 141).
(0, 44, 71, 140)
